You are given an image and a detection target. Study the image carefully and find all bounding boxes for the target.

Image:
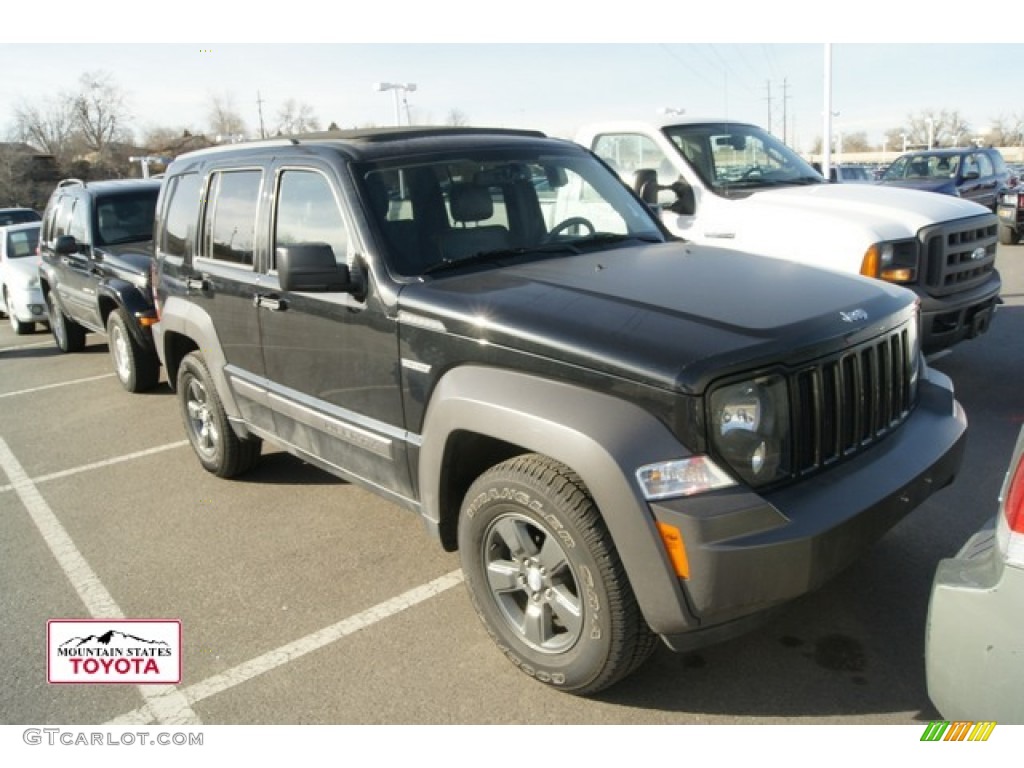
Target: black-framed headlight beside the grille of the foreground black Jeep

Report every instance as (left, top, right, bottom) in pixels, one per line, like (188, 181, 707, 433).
(709, 375, 790, 486)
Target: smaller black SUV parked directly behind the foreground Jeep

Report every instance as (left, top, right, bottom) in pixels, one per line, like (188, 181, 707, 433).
(39, 179, 160, 392)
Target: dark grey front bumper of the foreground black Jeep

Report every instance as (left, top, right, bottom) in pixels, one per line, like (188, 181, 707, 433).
(651, 371, 967, 650)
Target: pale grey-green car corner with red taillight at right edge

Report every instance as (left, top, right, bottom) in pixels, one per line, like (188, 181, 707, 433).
(925, 428, 1024, 725)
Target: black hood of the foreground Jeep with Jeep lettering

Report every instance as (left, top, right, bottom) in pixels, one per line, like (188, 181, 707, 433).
(399, 243, 915, 393)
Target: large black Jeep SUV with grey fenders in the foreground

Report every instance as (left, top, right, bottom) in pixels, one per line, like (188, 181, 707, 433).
(154, 128, 966, 693)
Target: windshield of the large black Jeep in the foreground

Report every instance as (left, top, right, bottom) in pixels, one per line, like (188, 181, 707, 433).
(358, 150, 665, 276)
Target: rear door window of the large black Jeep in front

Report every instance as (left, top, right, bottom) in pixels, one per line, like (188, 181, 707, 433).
(202, 170, 263, 267)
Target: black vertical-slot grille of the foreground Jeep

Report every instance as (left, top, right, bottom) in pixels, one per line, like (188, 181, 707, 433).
(792, 328, 914, 475)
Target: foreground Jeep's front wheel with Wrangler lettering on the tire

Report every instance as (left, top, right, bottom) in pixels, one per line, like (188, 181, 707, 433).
(459, 455, 656, 695)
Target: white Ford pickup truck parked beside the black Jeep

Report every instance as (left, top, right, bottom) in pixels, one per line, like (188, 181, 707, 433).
(571, 117, 1001, 354)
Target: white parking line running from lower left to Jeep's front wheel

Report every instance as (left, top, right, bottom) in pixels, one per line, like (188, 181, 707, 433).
(105, 570, 463, 725)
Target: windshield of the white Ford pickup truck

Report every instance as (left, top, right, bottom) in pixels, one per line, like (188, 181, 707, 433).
(664, 123, 824, 197)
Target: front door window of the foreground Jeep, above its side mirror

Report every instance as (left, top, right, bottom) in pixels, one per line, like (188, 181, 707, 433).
(272, 170, 348, 264)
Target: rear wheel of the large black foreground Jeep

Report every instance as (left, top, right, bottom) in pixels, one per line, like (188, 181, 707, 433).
(177, 352, 261, 477)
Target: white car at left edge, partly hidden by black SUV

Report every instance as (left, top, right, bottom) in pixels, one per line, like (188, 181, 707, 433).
(0, 221, 48, 334)
